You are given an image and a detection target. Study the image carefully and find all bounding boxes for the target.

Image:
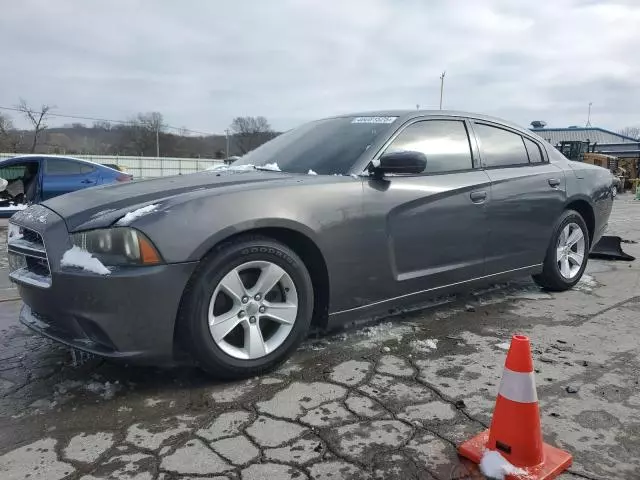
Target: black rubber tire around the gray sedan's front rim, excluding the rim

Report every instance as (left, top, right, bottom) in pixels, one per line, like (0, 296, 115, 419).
(178, 235, 314, 379)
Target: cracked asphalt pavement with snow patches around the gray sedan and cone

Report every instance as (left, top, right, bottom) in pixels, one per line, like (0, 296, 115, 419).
(0, 196, 640, 480)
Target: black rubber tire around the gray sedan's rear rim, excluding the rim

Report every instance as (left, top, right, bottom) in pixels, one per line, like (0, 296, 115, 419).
(533, 210, 591, 292)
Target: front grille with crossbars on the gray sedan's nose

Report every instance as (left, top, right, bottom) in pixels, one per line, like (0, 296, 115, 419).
(7, 223, 51, 288)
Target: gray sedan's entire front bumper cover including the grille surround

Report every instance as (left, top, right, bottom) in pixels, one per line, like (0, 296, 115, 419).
(9, 202, 197, 364)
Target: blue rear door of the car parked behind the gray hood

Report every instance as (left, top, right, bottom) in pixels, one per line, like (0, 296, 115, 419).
(42, 158, 99, 200)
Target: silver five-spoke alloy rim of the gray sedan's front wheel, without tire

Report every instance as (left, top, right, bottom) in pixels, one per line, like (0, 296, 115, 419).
(208, 260, 298, 360)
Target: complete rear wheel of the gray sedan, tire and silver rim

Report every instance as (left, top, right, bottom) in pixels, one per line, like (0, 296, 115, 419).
(533, 210, 590, 292)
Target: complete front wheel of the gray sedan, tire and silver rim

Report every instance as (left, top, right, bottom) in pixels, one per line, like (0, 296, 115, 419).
(180, 236, 313, 378)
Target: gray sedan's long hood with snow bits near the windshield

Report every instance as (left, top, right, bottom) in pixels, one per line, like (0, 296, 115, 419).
(42, 171, 297, 231)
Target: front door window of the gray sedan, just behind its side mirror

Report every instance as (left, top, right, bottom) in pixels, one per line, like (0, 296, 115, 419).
(385, 120, 473, 173)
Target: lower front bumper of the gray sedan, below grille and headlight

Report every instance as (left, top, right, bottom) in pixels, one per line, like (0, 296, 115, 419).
(18, 263, 195, 364)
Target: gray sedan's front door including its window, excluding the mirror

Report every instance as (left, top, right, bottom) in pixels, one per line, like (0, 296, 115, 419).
(365, 117, 490, 297)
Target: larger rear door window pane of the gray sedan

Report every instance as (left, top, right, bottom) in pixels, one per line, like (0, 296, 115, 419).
(473, 123, 529, 167)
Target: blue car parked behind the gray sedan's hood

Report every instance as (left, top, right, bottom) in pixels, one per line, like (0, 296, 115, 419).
(0, 155, 133, 218)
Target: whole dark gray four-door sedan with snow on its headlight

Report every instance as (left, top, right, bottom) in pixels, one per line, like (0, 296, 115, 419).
(9, 111, 614, 377)
